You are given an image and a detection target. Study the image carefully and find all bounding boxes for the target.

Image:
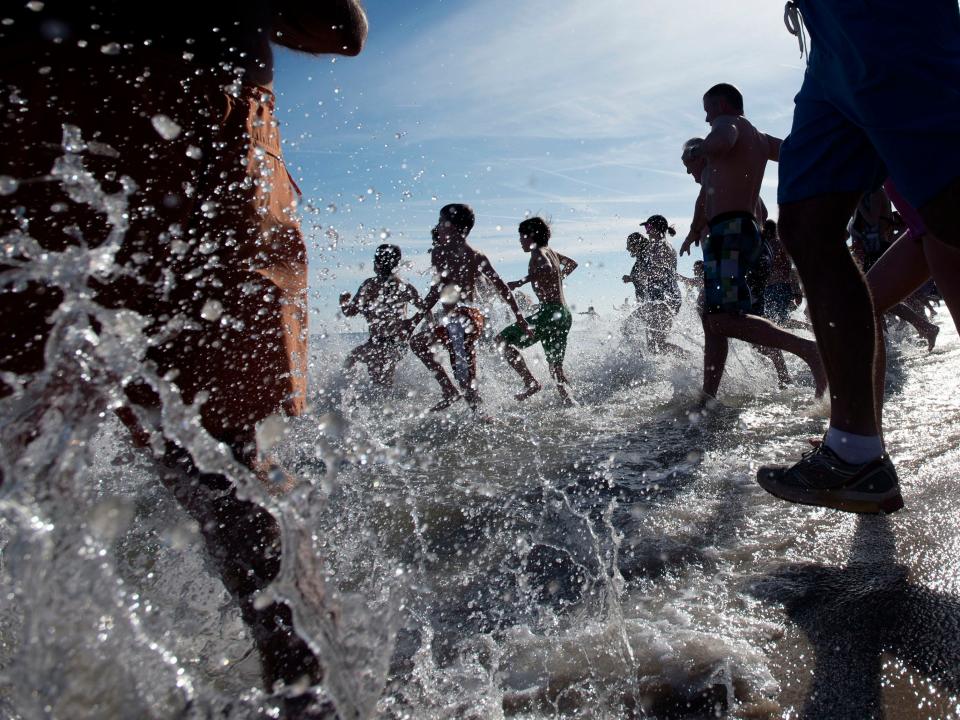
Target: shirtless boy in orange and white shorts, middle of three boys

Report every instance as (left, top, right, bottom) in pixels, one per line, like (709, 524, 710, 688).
(410, 204, 532, 411)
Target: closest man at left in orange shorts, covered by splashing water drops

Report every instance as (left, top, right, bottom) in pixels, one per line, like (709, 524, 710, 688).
(0, 0, 367, 713)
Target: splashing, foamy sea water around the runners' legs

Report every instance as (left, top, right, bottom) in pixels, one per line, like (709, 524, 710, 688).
(7, 262, 960, 719)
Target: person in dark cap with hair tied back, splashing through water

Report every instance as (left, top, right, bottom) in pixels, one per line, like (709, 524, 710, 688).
(623, 215, 685, 355)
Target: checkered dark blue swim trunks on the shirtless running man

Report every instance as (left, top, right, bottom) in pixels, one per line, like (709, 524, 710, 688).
(703, 212, 762, 315)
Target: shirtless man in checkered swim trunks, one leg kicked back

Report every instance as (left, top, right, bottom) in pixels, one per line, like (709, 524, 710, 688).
(680, 83, 826, 403)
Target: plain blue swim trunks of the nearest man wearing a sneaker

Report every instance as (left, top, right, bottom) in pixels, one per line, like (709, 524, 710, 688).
(777, 0, 960, 207)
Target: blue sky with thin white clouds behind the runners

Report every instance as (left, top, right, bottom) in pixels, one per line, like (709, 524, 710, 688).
(275, 0, 804, 333)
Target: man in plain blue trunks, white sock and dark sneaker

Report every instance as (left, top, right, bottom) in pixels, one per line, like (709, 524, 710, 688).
(757, 0, 960, 512)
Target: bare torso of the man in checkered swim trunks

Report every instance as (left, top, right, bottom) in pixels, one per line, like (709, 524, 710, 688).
(700, 115, 771, 220)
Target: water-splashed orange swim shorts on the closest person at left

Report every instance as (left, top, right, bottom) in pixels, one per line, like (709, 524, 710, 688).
(0, 48, 307, 441)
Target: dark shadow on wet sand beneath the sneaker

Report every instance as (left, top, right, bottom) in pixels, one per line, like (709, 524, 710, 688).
(751, 516, 960, 720)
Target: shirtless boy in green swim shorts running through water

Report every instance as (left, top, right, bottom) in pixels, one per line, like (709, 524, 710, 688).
(497, 217, 577, 405)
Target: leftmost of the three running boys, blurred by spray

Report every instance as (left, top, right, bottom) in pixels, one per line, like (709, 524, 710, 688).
(340, 245, 423, 387)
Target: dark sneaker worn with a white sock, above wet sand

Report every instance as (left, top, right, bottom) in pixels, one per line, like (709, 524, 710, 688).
(757, 445, 903, 513)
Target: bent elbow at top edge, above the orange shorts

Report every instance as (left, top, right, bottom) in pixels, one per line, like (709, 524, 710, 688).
(272, 0, 367, 55)
